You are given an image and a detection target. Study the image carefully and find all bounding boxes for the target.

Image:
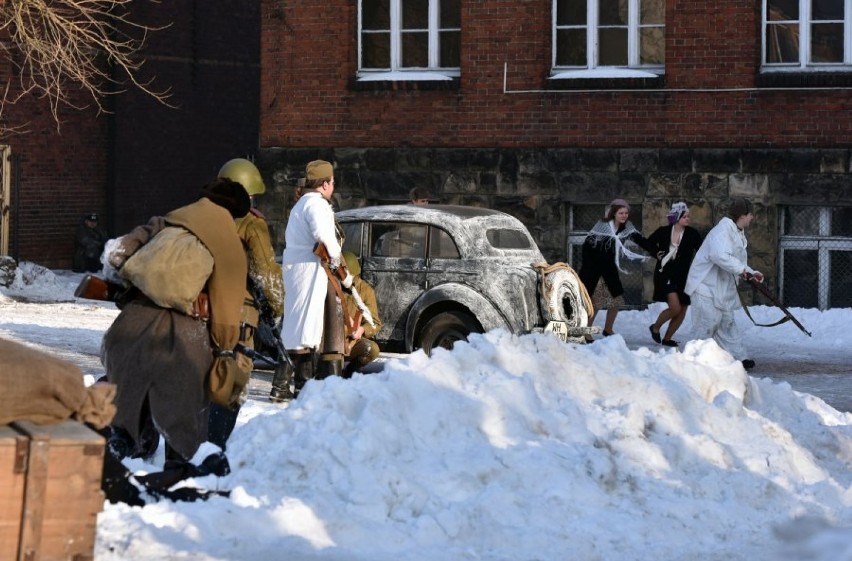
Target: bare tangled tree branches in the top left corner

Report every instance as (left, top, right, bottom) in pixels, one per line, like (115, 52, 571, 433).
(0, 0, 169, 131)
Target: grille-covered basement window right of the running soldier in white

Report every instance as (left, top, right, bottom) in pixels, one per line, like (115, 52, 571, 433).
(778, 206, 852, 310)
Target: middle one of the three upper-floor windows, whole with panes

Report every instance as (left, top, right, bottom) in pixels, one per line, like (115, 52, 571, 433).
(553, 0, 666, 77)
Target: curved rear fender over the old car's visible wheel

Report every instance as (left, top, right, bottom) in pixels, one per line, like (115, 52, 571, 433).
(405, 283, 510, 352)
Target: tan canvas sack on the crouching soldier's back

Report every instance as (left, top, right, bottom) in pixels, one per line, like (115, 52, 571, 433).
(119, 226, 213, 315)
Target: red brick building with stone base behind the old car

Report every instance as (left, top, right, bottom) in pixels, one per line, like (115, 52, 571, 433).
(258, 0, 852, 308)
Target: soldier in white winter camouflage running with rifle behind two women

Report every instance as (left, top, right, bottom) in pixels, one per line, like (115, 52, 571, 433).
(684, 197, 763, 369)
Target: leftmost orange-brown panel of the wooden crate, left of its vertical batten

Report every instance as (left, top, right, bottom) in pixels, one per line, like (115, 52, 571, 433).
(0, 425, 29, 559)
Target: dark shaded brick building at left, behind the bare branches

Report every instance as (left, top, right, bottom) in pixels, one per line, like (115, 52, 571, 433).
(0, 0, 260, 268)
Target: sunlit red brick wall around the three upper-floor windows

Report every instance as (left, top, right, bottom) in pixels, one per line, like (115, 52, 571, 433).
(260, 0, 852, 148)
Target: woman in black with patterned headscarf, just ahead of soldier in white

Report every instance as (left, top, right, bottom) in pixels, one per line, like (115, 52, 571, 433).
(648, 202, 701, 347)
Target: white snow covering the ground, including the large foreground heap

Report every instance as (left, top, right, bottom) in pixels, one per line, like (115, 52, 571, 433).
(0, 263, 852, 561)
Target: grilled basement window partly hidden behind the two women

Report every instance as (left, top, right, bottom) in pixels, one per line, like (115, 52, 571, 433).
(566, 203, 644, 308)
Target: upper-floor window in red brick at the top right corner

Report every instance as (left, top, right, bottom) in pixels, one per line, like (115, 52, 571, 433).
(763, 0, 852, 71)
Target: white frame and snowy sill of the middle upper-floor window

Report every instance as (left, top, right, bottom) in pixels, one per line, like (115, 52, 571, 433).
(550, 0, 664, 79)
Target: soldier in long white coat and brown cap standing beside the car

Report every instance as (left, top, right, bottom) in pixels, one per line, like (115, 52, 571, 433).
(270, 160, 352, 402)
